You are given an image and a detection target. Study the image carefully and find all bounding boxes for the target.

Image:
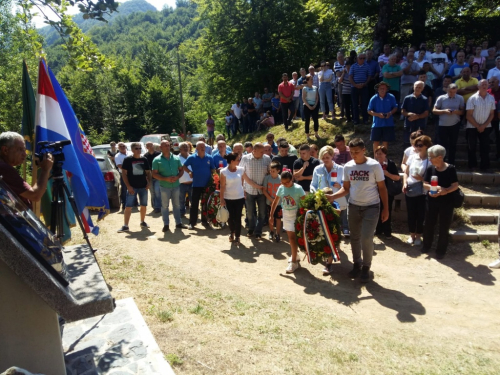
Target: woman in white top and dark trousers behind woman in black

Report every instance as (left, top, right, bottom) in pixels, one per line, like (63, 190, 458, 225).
(403, 135, 432, 246)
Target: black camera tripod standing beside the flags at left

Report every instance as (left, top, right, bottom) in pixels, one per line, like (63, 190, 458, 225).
(50, 159, 96, 253)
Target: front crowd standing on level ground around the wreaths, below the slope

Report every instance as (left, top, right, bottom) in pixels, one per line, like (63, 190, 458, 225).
(103, 114, 500, 282)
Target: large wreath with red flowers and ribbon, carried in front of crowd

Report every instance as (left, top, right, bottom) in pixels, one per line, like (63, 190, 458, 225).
(295, 190, 341, 264)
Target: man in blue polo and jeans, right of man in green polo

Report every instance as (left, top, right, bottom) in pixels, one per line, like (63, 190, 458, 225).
(184, 141, 215, 229)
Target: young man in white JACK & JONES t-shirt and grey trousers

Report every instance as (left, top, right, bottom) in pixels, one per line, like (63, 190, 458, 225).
(327, 138, 389, 283)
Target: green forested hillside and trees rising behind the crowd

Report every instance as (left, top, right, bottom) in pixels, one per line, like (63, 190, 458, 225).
(0, 0, 500, 144)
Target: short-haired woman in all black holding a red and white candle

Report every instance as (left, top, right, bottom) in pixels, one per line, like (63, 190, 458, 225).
(422, 145, 458, 259)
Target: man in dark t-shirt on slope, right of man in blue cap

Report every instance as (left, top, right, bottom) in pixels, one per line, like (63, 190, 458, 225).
(403, 81, 429, 149)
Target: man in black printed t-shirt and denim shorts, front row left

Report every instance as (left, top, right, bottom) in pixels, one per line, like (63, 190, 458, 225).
(118, 142, 151, 232)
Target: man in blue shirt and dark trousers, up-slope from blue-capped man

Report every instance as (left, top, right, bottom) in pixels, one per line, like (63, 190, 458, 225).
(349, 53, 371, 125)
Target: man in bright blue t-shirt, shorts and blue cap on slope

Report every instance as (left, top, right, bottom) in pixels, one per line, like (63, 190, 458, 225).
(368, 81, 398, 154)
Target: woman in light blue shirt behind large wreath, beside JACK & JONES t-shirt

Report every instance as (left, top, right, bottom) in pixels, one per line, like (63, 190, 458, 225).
(311, 146, 349, 276)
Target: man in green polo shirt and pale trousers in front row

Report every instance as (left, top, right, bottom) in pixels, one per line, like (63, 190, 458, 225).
(153, 140, 186, 232)
